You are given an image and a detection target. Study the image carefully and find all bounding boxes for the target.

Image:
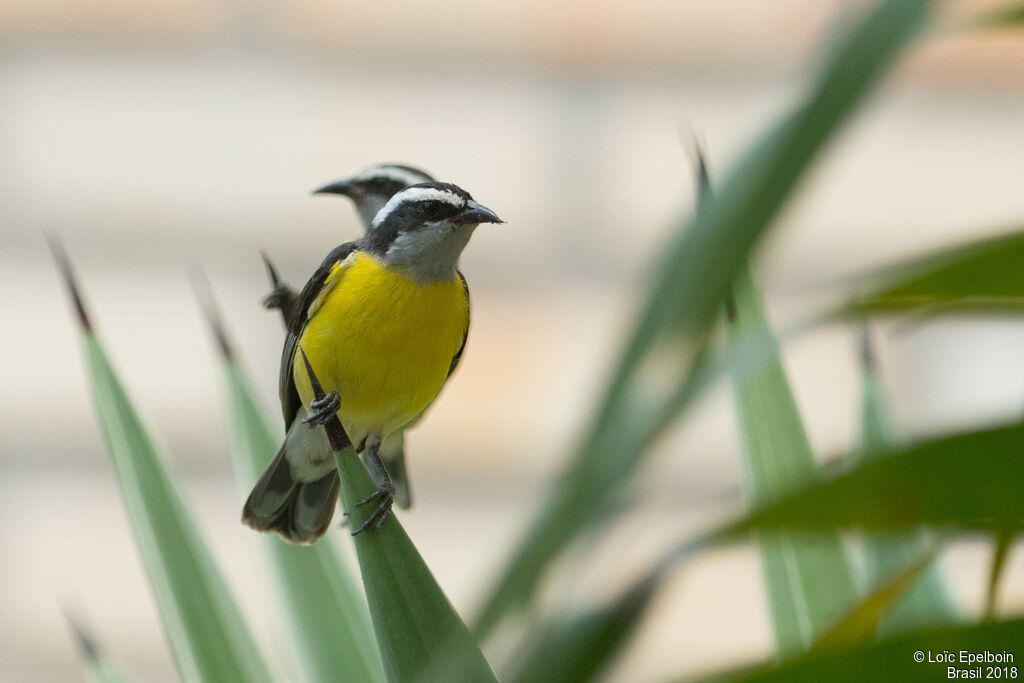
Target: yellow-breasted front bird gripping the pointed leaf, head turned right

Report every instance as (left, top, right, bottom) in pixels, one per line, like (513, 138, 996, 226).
(242, 182, 502, 543)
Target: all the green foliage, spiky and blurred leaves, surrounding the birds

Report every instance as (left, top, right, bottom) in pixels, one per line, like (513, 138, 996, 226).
(57, 0, 1024, 682)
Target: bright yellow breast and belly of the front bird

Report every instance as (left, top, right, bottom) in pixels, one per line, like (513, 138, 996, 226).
(293, 252, 469, 442)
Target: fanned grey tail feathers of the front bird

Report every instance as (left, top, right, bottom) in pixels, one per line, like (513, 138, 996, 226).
(242, 444, 340, 544)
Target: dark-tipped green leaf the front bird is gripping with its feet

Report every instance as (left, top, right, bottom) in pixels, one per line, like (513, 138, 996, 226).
(299, 348, 498, 683)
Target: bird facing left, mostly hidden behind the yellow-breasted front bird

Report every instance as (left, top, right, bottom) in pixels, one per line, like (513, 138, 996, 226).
(263, 164, 434, 509)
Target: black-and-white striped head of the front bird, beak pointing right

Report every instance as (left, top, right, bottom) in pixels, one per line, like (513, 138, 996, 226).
(365, 182, 504, 282)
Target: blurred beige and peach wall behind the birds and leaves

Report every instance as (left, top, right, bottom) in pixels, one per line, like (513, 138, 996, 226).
(0, 0, 1024, 681)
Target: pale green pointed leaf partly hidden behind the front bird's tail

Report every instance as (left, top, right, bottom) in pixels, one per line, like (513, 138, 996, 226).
(225, 357, 384, 683)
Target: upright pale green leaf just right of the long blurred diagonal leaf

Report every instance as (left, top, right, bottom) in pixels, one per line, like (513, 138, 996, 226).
(729, 270, 857, 655)
